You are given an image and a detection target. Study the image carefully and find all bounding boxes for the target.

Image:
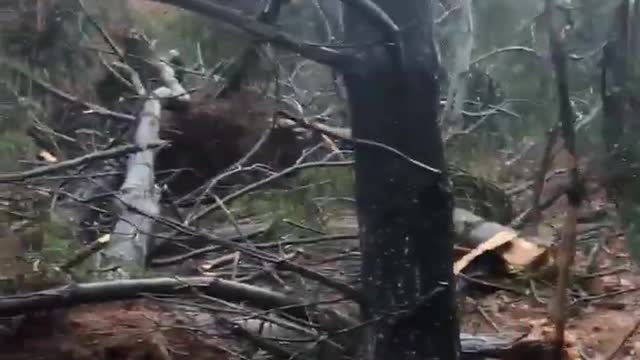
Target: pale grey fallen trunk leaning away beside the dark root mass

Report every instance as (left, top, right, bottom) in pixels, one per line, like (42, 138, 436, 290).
(96, 31, 190, 278)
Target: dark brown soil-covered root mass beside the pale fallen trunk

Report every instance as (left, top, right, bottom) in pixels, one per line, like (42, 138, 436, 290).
(157, 91, 311, 194)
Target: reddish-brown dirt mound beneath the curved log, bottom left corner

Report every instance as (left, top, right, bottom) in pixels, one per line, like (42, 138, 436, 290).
(0, 301, 229, 360)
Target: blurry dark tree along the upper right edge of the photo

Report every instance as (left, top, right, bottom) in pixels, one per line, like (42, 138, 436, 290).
(600, 0, 640, 263)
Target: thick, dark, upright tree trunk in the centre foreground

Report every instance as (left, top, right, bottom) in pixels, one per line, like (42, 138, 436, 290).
(344, 0, 459, 360)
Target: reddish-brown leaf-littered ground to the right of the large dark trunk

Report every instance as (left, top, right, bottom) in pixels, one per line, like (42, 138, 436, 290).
(462, 228, 640, 360)
